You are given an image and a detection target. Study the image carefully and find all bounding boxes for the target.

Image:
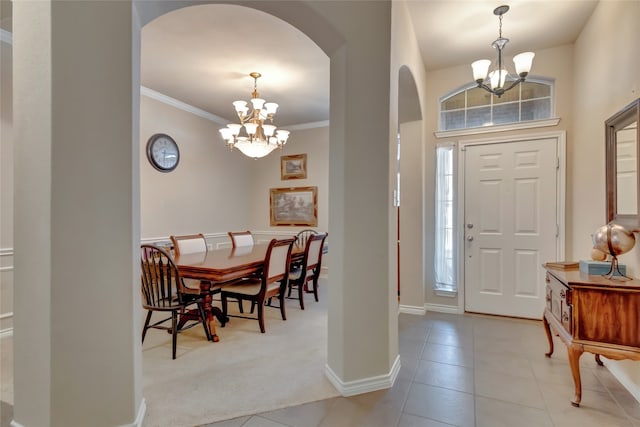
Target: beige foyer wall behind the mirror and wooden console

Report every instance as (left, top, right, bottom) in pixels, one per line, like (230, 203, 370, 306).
(567, 1, 640, 399)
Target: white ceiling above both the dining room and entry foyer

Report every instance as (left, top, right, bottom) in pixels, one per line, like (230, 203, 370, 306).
(141, 0, 597, 129)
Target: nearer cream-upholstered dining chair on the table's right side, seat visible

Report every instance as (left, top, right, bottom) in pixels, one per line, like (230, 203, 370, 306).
(222, 238, 295, 333)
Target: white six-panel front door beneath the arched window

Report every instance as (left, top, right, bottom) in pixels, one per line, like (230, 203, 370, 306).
(463, 138, 558, 319)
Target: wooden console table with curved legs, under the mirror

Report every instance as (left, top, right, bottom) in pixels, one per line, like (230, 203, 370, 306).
(543, 267, 640, 406)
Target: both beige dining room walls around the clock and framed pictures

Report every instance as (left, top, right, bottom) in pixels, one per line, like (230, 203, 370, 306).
(140, 96, 329, 239)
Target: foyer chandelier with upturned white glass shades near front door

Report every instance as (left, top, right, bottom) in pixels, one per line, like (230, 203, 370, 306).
(471, 5, 535, 98)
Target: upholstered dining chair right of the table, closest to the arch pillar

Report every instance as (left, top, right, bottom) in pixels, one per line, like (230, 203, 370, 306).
(287, 233, 329, 310)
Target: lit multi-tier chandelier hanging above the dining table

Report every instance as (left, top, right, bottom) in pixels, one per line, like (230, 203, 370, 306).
(220, 72, 289, 159)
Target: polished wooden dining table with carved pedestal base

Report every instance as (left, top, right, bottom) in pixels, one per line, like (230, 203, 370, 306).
(174, 243, 305, 342)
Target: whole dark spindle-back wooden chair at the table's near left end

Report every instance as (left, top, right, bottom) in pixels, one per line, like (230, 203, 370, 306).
(140, 244, 212, 359)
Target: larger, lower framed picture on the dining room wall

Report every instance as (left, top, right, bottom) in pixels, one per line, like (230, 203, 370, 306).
(269, 187, 318, 227)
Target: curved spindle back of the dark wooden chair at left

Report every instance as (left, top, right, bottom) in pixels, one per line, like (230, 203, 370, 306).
(140, 244, 188, 310)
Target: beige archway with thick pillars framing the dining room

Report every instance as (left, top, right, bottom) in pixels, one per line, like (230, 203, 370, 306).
(13, 1, 399, 426)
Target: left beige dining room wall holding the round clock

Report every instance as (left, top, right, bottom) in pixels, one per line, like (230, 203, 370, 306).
(140, 96, 255, 239)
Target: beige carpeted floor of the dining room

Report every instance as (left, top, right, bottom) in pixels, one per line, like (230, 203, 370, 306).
(142, 279, 339, 427)
